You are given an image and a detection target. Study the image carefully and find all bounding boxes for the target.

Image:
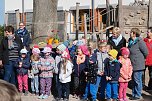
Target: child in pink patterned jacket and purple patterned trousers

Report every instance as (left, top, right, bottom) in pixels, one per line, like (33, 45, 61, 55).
(39, 47, 55, 99)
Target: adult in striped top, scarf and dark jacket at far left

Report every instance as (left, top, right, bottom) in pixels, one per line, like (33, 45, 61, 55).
(0, 26, 23, 84)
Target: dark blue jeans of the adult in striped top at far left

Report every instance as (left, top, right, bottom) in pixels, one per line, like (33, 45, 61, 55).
(4, 61, 16, 85)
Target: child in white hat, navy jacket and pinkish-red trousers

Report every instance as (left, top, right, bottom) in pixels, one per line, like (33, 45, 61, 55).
(15, 49, 30, 96)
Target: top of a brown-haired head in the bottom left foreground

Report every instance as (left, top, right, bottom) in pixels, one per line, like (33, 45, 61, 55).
(0, 80, 21, 101)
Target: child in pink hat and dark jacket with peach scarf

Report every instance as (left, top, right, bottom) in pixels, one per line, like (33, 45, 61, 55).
(73, 45, 89, 99)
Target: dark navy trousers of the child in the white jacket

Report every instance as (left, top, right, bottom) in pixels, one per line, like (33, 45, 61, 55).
(58, 82, 70, 99)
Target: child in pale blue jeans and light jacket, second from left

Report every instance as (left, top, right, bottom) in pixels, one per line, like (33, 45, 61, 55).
(31, 48, 40, 95)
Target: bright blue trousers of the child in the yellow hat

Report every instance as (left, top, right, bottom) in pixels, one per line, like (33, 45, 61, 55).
(106, 82, 118, 99)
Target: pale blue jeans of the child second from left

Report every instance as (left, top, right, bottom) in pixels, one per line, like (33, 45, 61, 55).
(31, 76, 39, 93)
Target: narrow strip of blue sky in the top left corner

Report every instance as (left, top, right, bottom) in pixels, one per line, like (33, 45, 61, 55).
(0, 0, 5, 25)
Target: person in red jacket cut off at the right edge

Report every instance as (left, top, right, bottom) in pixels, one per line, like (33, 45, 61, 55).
(144, 28, 152, 90)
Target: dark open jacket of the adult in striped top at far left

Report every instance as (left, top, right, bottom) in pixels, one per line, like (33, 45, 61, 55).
(0, 35, 23, 65)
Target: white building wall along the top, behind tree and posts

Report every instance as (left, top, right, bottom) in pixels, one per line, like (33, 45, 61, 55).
(5, 0, 143, 12)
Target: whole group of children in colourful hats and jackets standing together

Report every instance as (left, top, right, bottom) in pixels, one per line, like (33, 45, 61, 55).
(15, 40, 132, 101)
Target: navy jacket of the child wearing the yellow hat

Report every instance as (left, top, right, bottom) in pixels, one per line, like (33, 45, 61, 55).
(104, 60, 121, 83)
